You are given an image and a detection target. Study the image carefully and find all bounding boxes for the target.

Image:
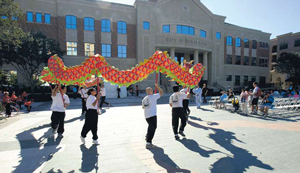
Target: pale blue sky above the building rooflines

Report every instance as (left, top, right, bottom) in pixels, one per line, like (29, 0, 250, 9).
(104, 0, 300, 38)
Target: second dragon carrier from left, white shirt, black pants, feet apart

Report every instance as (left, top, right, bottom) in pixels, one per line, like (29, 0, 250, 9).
(80, 88, 100, 145)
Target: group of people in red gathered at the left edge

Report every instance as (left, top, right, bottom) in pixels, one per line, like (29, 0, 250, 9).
(0, 90, 34, 117)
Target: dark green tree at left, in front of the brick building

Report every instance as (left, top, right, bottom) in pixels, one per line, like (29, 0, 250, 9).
(0, 32, 64, 94)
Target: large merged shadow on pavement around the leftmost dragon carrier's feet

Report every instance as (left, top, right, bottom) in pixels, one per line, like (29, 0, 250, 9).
(12, 117, 81, 173)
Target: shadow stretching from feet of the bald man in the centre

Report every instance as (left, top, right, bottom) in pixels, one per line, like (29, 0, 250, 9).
(149, 147, 191, 173)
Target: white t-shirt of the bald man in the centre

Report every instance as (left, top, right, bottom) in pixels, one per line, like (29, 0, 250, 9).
(142, 93, 160, 118)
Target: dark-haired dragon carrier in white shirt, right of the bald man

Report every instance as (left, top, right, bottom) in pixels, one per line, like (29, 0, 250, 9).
(169, 85, 190, 140)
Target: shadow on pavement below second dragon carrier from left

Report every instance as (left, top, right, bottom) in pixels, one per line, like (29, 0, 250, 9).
(80, 144, 99, 172)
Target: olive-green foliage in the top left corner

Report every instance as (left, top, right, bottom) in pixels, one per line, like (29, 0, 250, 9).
(0, 0, 25, 52)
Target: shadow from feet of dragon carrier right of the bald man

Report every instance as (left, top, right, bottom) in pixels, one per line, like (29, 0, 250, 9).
(179, 138, 219, 157)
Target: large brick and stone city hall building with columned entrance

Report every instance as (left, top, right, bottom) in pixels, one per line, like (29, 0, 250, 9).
(1, 0, 271, 92)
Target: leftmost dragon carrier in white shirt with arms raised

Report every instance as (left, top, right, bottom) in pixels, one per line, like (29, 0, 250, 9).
(51, 85, 70, 138)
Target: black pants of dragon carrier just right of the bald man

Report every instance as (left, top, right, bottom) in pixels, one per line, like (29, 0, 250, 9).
(172, 108, 186, 135)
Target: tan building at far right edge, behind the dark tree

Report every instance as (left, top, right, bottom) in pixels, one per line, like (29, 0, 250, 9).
(270, 32, 300, 89)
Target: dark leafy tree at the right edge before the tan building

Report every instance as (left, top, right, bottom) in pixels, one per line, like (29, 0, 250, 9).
(274, 53, 300, 86)
